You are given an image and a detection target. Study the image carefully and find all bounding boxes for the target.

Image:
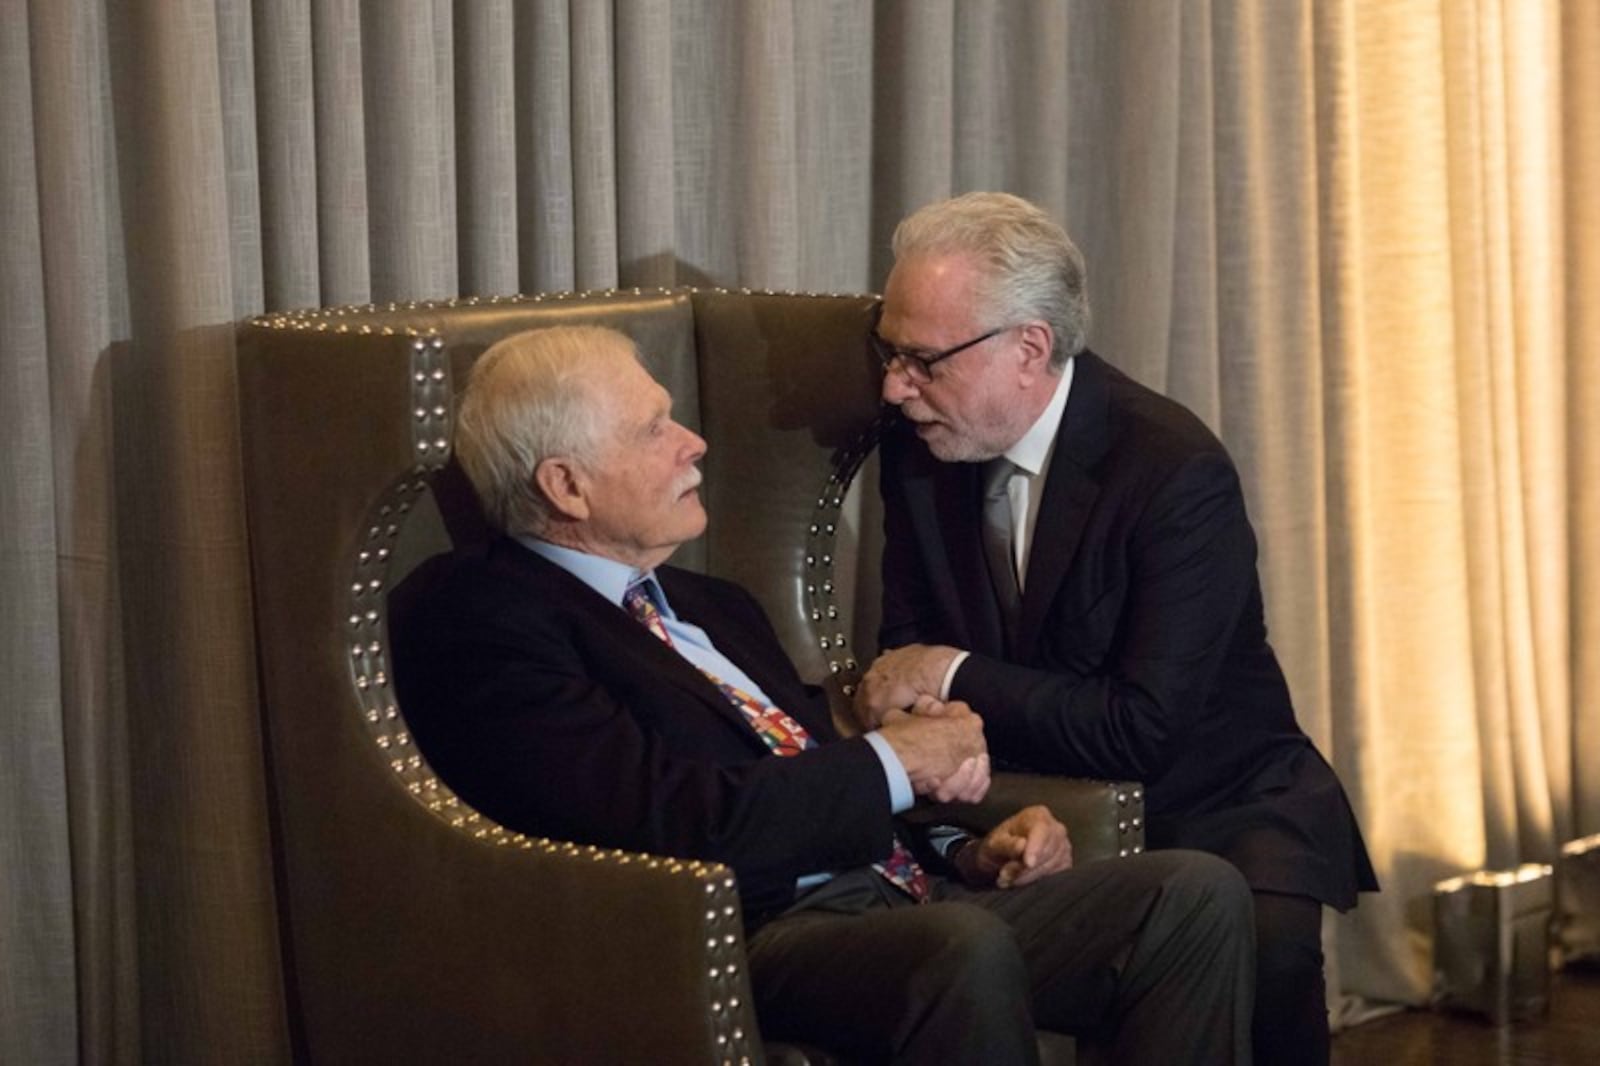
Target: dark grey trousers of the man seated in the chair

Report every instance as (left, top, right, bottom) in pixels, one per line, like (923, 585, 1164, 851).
(749, 852, 1254, 1066)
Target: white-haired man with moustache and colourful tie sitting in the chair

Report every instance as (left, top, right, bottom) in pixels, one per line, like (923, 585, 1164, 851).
(392, 328, 1254, 1066)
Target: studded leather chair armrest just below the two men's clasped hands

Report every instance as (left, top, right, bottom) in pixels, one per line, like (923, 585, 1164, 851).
(909, 771, 1144, 866)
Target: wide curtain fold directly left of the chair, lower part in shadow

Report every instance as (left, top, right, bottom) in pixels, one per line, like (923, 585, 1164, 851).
(104, 0, 286, 1061)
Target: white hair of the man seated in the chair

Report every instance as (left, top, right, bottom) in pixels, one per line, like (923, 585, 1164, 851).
(454, 327, 638, 533)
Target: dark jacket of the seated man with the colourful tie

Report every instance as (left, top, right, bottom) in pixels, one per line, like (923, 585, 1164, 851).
(390, 539, 894, 917)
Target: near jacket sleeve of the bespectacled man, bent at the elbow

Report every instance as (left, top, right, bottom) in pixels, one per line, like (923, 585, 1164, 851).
(950, 451, 1256, 781)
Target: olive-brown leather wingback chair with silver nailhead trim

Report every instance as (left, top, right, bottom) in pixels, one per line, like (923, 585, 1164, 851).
(238, 290, 1142, 1064)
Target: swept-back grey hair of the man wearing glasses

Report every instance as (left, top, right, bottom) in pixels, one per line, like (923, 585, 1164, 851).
(893, 192, 1090, 370)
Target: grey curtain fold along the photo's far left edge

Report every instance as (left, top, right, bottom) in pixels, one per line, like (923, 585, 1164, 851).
(0, 2, 77, 1061)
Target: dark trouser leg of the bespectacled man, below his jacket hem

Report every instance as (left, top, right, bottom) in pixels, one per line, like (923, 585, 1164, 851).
(1251, 892, 1328, 1066)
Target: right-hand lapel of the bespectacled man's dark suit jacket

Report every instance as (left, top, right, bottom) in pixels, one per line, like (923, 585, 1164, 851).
(1018, 351, 1110, 661)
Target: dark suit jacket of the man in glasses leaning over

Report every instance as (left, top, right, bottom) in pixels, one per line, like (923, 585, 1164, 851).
(880, 352, 1376, 908)
